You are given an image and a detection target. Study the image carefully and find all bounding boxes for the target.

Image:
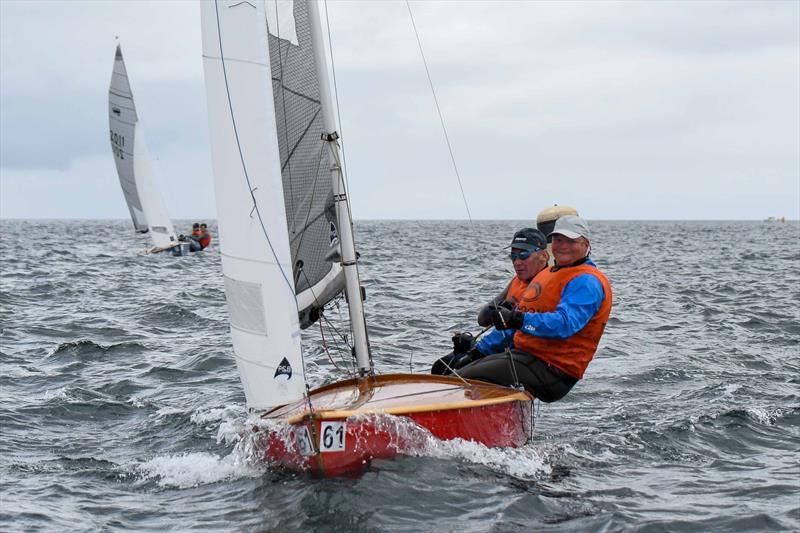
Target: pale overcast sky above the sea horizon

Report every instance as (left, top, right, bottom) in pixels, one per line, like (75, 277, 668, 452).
(0, 0, 800, 220)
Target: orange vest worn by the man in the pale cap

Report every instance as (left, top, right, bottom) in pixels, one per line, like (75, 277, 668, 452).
(514, 263, 611, 379)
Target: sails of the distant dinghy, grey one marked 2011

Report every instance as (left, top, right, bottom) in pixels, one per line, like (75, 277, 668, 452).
(108, 45, 177, 248)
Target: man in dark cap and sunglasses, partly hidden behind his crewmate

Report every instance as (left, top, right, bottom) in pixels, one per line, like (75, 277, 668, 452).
(431, 228, 549, 375)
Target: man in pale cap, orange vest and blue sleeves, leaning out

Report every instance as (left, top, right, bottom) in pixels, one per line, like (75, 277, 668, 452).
(458, 215, 611, 402)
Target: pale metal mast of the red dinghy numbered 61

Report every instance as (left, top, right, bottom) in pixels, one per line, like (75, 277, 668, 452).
(306, 0, 372, 376)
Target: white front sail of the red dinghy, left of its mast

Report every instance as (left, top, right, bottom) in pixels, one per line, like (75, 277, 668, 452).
(201, 0, 305, 409)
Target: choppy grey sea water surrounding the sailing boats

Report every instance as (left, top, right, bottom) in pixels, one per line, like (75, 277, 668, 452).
(0, 220, 800, 532)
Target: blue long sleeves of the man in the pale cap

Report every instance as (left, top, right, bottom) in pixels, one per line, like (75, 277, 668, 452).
(476, 260, 605, 355)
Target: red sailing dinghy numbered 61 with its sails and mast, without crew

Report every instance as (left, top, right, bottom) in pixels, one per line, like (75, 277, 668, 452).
(201, 0, 532, 475)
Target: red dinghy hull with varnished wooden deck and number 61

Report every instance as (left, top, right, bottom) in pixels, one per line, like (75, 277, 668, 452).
(259, 374, 533, 476)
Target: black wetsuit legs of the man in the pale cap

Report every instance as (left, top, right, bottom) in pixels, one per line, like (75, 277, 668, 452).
(458, 350, 578, 402)
